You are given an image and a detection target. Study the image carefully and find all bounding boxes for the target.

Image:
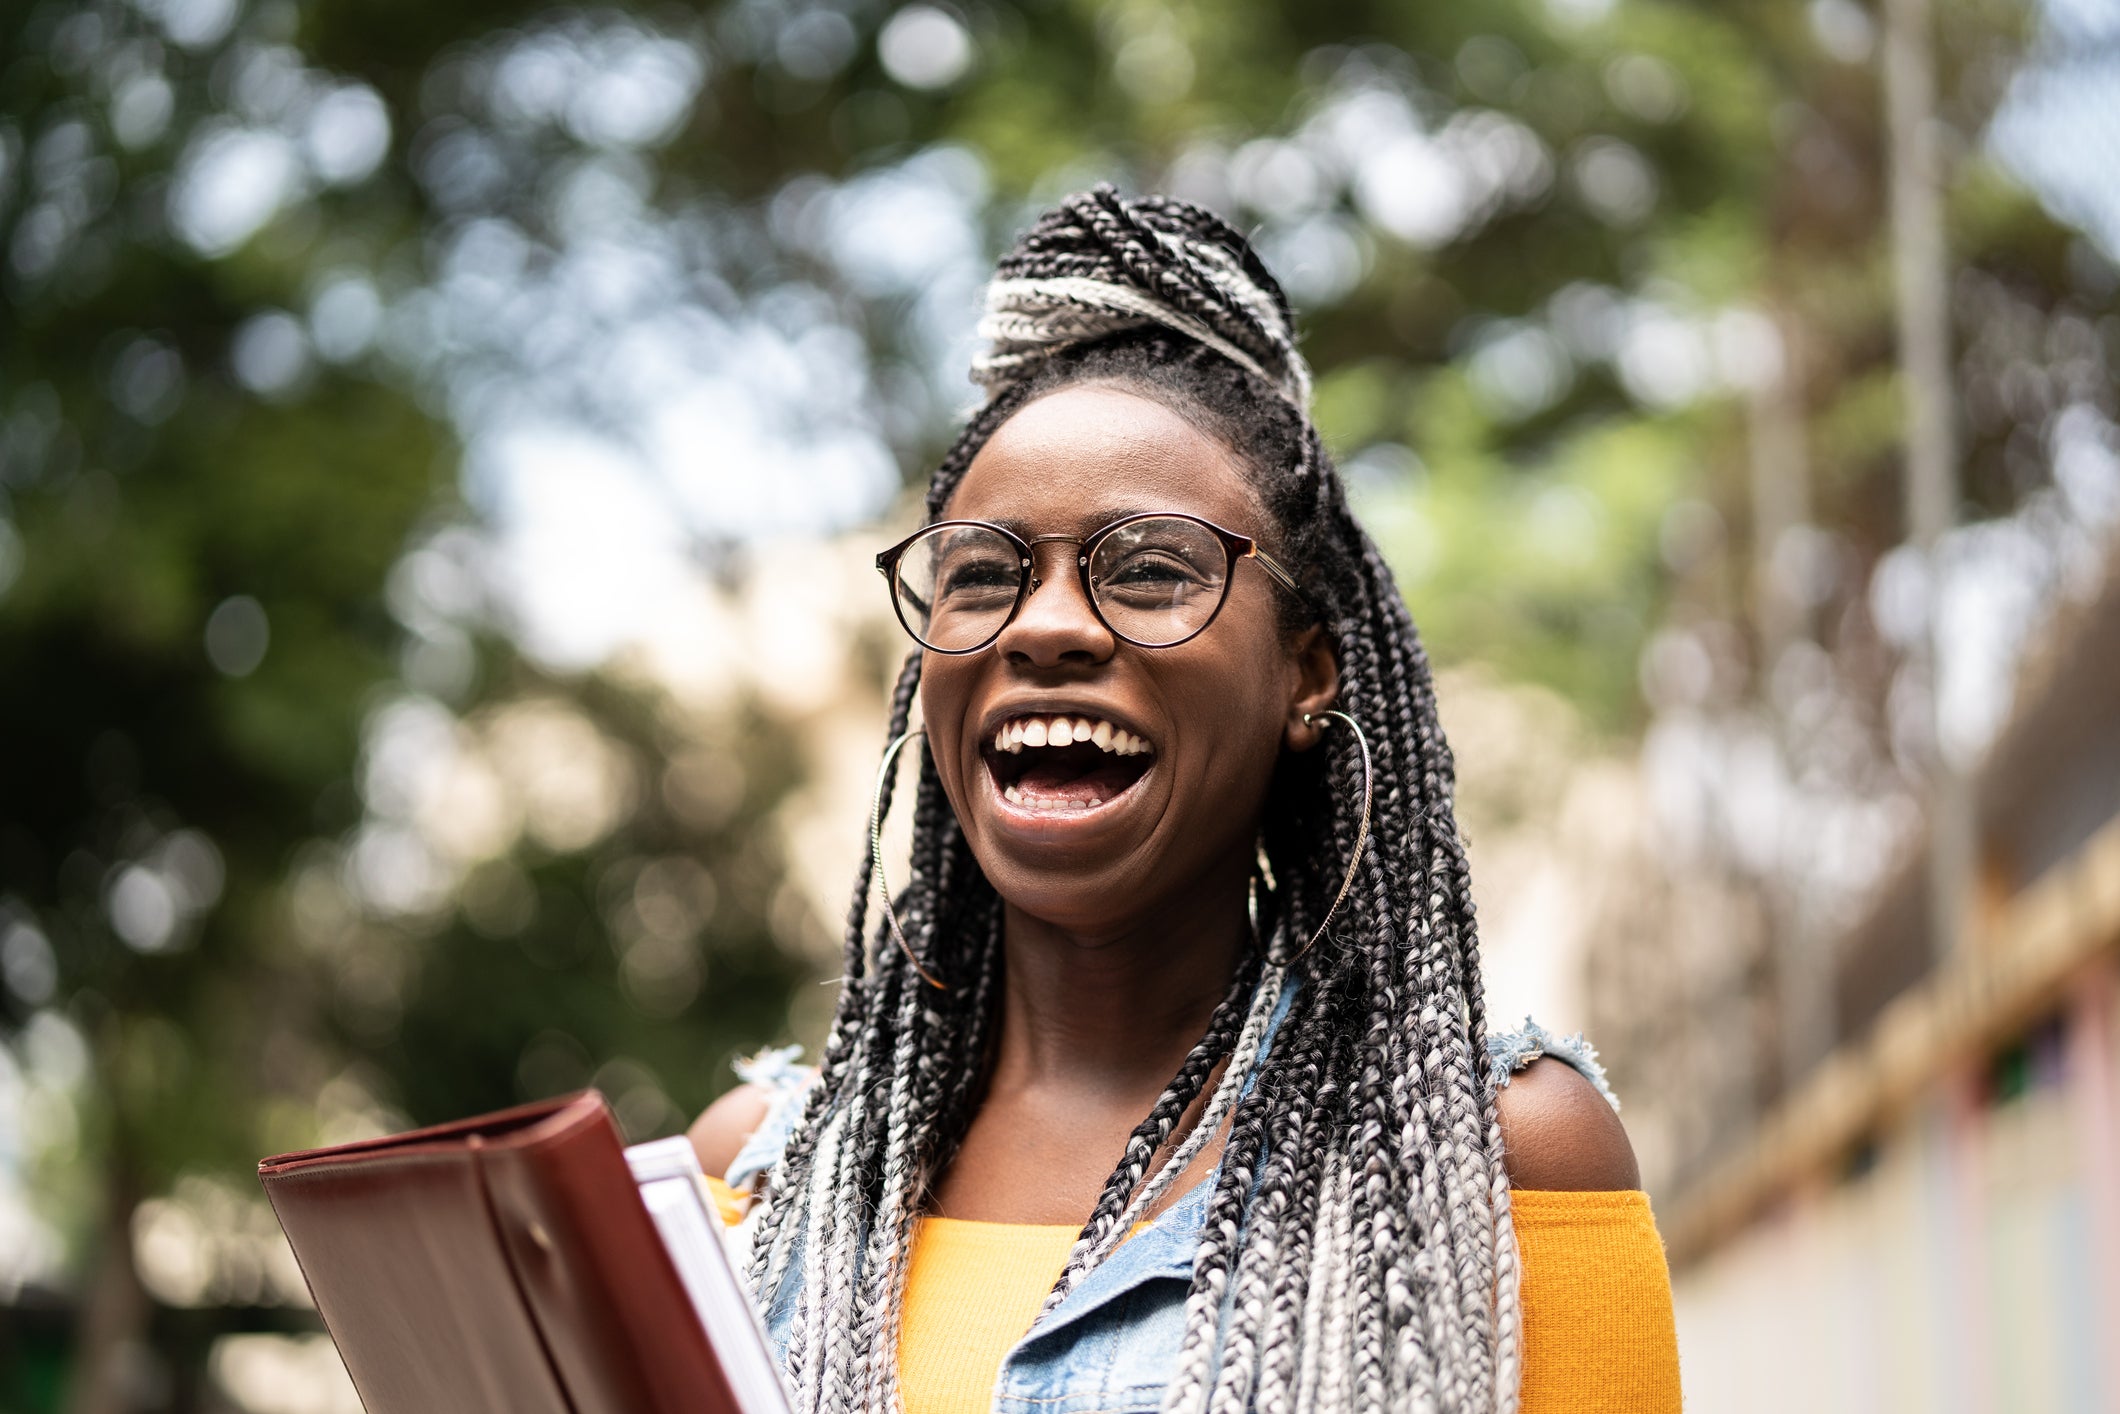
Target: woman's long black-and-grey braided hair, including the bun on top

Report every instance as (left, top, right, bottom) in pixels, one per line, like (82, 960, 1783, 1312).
(748, 187, 1520, 1414)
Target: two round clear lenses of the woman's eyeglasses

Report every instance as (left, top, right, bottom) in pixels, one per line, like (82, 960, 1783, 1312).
(893, 515, 1230, 653)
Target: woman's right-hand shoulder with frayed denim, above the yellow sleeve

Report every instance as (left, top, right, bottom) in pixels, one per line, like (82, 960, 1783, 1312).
(1488, 1018, 1641, 1191)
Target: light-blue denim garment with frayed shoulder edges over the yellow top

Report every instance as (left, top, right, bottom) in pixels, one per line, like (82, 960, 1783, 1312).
(727, 1004, 1618, 1414)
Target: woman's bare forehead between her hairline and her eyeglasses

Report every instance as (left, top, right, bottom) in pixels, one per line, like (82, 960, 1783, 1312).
(946, 386, 1261, 534)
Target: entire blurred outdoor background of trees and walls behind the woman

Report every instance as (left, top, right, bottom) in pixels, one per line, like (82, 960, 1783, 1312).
(0, 0, 2120, 1414)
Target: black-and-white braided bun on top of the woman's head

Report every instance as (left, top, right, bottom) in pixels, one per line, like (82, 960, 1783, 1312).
(971, 184, 1310, 409)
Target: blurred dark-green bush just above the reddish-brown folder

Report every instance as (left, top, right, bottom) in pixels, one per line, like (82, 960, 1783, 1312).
(331, 664, 808, 1138)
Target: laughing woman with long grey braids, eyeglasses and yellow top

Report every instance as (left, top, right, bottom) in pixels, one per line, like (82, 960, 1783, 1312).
(693, 189, 1677, 1414)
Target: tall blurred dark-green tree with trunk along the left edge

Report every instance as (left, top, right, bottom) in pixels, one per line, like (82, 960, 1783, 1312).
(0, 6, 447, 1412)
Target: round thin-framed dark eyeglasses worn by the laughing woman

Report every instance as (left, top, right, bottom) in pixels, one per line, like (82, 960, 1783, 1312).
(876, 511, 1310, 653)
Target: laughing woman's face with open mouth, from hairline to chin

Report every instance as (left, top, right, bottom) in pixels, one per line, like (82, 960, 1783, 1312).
(920, 386, 1338, 937)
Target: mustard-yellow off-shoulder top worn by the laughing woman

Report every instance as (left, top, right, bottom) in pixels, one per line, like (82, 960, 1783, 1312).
(708, 1179, 1679, 1414)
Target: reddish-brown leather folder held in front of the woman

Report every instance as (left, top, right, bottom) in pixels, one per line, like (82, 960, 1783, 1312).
(259, 1090, 742, 1414)
